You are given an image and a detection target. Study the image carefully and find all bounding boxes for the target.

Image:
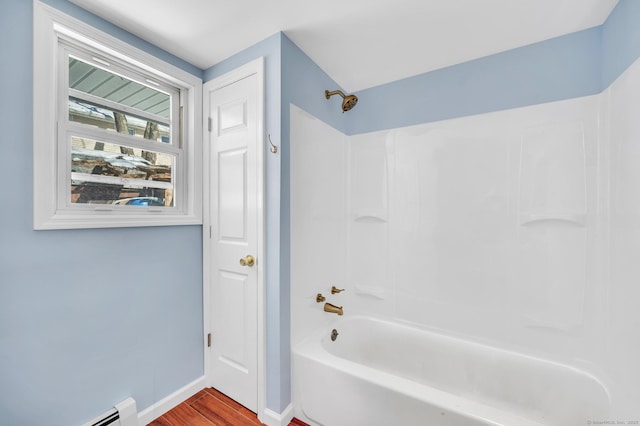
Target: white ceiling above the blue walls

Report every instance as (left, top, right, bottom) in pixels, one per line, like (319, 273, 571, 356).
(70, 0, 618, 92)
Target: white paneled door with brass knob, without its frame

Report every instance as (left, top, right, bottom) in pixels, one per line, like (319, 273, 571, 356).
(204, 63, 263, 412)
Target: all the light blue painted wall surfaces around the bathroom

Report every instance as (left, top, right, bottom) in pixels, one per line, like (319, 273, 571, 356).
(0, 0, 640, 425)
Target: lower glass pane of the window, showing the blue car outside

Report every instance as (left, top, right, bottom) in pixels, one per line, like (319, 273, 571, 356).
(71, 137, 175, 207)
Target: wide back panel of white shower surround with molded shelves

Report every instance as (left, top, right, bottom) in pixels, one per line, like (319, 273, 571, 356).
(347, 97, 601, 361)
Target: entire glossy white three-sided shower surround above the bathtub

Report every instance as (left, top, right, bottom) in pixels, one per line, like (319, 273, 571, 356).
(291, 55, 640, 421)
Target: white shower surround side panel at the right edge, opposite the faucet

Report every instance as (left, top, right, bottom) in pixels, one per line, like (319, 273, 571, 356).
(605, 55, 640, 420)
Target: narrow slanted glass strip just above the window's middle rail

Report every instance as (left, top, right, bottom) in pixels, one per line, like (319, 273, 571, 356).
(69, 97, 171, 143)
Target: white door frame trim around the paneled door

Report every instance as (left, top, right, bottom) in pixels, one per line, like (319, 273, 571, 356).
(202, 57, 266, 422)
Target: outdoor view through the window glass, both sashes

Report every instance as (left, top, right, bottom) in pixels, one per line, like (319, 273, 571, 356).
(67, 53, 178, 207)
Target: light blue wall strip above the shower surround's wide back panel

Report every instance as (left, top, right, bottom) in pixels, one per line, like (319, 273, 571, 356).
(349, 27, 602, 134)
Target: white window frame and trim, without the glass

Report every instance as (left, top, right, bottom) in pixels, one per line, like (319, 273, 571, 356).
(33, 0, 202, 229)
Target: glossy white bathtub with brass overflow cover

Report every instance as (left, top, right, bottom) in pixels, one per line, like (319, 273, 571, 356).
(293, 317, 609, 426)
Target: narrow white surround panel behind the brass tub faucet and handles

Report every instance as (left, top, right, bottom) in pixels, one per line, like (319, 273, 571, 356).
(291, 106, 350, 345)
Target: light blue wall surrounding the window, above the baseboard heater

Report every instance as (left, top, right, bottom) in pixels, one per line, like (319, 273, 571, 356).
(0, 0, 203, 426)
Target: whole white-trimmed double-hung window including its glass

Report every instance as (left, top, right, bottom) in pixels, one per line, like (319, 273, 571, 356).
(34, 3, 202, 229)
